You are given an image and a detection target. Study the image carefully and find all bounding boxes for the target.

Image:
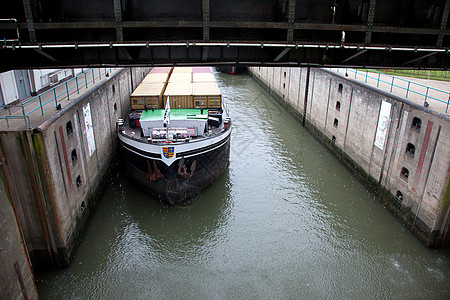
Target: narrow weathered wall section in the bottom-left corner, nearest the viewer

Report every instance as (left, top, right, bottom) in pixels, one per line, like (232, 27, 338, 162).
(0, 149, 38, 300)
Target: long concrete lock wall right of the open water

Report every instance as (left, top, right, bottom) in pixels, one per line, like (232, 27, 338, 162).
(250, 67, 450, 247)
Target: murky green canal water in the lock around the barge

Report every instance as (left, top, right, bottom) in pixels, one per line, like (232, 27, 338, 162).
(37, 69, 450, 299)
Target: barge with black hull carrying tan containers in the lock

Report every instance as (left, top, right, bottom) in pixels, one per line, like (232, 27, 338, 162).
(118, 67, 232, 205)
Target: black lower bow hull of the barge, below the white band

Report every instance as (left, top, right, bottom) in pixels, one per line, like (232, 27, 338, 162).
(120, 138, 230, 205)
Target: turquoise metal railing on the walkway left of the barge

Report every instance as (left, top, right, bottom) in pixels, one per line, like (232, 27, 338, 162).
(0, 68, 116, 128)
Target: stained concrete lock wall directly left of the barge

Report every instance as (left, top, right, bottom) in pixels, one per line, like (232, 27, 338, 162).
(0, 68, 150, 269)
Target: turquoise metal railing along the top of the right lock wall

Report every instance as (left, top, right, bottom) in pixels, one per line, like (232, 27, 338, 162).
(330, 68, 450, 113)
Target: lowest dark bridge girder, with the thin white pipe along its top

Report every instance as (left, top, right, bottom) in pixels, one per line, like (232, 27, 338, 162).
(0, 42, 448, 71)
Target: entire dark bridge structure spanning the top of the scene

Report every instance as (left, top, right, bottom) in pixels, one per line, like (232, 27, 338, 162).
(0, 0, 450, 71)
